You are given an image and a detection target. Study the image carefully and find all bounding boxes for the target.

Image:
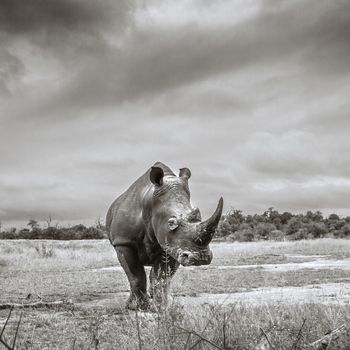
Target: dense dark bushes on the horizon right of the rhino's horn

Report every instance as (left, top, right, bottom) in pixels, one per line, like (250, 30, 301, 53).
(216, 208, 350, 241)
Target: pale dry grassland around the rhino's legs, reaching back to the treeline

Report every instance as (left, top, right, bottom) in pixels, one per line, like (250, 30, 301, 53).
(0, 239, 350, 350)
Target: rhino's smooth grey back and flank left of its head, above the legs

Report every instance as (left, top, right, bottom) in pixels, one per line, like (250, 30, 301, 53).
(106, 162, 173, 245)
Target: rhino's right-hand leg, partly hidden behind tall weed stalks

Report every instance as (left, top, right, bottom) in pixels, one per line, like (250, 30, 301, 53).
(149, 257, 179, 306)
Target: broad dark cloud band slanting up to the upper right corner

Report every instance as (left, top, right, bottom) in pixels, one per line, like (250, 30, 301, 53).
(47, 1, 350, 110)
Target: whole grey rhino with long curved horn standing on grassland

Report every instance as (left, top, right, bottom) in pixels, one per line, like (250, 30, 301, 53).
(106, 162, 223, 309)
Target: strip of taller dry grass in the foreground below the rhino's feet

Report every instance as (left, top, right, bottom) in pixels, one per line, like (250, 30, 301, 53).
(2, 304, 350, 350)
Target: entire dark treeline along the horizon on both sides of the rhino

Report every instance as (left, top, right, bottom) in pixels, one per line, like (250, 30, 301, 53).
(0, 208, 350, 241)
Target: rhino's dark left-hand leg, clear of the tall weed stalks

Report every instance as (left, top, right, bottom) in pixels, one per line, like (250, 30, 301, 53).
(115, 246, 150, 310)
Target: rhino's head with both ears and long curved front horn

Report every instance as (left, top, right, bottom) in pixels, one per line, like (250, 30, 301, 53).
(150, 167, 223, 266)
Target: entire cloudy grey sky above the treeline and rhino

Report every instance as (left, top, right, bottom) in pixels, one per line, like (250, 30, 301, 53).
(0, 0, 350, 225)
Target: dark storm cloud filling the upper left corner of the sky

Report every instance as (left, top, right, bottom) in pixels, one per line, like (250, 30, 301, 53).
(0, 0, 134, 97)
